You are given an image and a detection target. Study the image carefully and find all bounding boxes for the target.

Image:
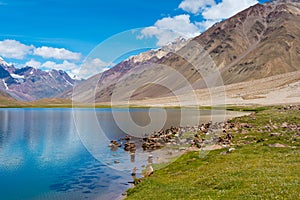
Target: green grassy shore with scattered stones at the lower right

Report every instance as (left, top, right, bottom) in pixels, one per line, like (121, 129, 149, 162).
(126, 107, 300, 200)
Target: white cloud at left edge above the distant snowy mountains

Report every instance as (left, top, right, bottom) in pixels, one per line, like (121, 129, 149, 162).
(0, 40, 34, 59)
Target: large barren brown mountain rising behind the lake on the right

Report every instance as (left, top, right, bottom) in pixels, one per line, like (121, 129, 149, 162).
(68, 0, 300, 102)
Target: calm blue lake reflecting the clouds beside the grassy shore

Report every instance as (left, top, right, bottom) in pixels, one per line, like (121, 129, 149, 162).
(0, 108, 240, 200)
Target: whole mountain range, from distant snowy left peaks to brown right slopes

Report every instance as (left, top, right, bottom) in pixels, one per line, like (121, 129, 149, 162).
(0, 0, 300, 106)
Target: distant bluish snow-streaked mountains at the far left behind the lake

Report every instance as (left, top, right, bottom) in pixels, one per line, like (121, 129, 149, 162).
(0, 58, 75, 101)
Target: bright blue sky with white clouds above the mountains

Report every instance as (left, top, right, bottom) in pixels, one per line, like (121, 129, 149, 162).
(0, 0, 266, 76)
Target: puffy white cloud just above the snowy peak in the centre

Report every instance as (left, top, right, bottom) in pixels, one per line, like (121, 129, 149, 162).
(141, 15, 200, 46)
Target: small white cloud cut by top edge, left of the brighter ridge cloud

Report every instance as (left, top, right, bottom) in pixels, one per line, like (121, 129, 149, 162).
(178, 0, 216, 14)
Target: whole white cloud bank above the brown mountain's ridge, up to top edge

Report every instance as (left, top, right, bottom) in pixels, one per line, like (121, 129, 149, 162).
(140, 0, 258, 46)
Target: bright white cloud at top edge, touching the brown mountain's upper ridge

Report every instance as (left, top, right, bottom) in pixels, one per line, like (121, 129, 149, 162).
(202, 0, 258, 20)
